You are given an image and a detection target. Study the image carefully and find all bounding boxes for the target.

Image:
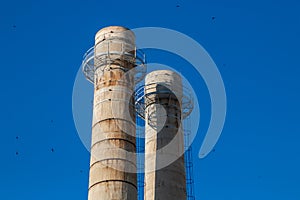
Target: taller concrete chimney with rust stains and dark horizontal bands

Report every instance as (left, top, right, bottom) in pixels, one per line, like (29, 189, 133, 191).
(88, 26, 137, 200)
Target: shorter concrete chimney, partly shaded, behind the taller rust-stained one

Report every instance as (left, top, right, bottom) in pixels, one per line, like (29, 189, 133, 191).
(144, 70, 186, 200)
